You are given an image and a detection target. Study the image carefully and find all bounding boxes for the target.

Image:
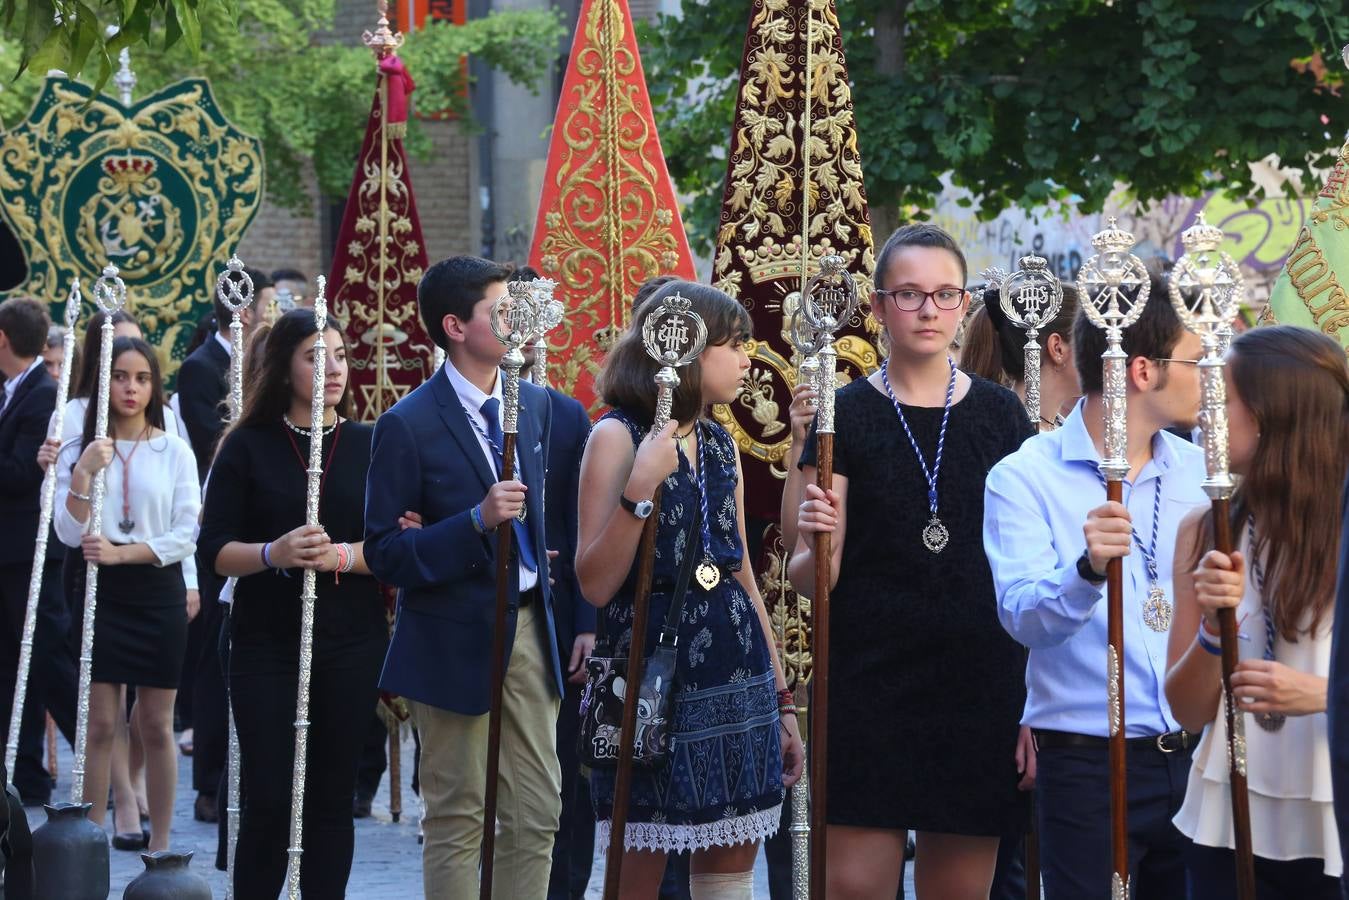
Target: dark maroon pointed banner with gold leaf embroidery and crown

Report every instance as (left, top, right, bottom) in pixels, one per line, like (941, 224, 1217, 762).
(714, 0, 880, 684)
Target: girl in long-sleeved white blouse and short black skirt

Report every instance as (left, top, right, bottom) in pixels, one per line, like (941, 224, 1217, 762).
(55, 337, 201, 851)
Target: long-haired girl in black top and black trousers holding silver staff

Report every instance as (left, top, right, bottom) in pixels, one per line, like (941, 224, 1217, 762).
(200, 309, 387, 900)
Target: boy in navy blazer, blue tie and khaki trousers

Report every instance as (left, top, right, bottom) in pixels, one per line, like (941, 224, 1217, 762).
(366, 256, 564, 900)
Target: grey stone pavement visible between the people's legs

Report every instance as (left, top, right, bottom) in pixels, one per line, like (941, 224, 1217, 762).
(27, 738, 913, 900)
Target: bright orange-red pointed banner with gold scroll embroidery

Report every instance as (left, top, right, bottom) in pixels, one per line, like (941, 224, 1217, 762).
(529, 0, 695, 412)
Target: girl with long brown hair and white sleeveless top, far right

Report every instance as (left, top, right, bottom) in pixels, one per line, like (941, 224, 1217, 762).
(1167, 325, 1349, 900)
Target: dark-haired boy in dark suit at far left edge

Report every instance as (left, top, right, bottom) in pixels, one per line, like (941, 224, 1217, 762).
(0, 297, 76, 804)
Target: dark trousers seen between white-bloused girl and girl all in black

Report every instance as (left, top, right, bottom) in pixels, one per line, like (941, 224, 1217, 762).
(191, 577, 227, 796)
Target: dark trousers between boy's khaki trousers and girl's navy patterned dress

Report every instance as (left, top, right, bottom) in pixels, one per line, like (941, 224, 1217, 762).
(548, 684, 595, 900)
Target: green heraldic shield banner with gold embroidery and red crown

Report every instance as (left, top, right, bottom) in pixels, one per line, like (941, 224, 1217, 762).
(0, 78, 263, 374)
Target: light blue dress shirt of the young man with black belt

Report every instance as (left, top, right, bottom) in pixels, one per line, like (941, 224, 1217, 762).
(983, 401, 1209, 738)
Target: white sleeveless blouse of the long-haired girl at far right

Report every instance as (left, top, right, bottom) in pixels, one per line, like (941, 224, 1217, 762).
(1175, 536, 1344, 878)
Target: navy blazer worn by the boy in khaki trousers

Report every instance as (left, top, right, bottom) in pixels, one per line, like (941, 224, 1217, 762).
(366, 371, 563, 715)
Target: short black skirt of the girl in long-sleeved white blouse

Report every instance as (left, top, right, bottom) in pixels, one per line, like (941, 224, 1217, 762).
(74, 551, 188, 690)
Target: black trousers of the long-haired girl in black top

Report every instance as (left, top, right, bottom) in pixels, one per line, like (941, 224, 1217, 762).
(229, 634, 387, 900)
